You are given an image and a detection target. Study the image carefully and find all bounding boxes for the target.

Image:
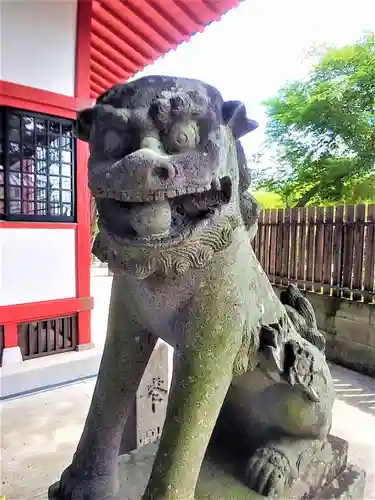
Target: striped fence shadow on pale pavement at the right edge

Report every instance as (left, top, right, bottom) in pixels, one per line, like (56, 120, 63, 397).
(331, 365, 375, 416)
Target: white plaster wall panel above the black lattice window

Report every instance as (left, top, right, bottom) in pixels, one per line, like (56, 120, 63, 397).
(0, 0, 77, 96)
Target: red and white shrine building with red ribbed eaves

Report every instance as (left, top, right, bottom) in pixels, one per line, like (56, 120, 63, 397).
(0, 0, 240, 374)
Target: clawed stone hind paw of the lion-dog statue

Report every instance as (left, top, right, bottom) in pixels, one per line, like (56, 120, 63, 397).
(245, 447, 292, 496)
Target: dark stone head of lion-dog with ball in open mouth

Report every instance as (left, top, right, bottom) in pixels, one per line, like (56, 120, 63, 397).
(77, 76, 257, 276)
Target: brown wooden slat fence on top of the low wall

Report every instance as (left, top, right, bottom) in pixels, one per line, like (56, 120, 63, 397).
(253, 204, 375, 303)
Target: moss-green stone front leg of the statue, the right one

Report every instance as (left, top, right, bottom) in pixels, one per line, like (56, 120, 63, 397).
(143, 290, 242, 500)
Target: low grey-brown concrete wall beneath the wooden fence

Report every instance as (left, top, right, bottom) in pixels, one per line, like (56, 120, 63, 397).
(275, 287, 375, 377)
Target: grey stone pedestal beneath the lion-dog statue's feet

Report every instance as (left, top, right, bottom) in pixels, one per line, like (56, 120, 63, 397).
(117, 437, 365, 500)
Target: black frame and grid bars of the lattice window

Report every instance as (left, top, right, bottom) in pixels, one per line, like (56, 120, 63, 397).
(0, 106, 77, 223)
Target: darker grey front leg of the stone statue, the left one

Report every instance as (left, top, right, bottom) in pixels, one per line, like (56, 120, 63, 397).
(48, 276, 157, 500)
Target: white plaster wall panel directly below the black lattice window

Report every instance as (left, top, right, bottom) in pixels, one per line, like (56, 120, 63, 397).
(0, 229, 76, 306)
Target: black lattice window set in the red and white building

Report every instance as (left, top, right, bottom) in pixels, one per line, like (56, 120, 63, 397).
(0, 108, 75, 222)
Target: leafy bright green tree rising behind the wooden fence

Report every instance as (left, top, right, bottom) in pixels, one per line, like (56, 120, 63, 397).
(263, 33, 375, 206)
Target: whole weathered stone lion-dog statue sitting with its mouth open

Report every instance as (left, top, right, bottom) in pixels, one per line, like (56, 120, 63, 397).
(49, 76, 334, 500)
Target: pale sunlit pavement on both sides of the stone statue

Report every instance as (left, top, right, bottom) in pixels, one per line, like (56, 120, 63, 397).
(0, 270, 375, 500)
